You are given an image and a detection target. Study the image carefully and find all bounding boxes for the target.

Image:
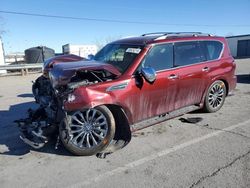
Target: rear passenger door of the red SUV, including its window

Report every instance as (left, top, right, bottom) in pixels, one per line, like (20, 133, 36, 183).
(174, 41, 209, 109)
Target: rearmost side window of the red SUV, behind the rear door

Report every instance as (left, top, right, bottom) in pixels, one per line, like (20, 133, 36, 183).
(203, 41, 223, 60)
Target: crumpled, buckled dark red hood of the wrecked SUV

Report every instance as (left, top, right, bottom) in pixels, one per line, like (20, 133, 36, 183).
(49, 61, 121, 86)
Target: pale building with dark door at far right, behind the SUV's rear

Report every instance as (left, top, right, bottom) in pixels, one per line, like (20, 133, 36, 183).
(226, 34, 250, 57)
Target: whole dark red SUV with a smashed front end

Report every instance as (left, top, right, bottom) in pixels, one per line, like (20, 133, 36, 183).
(17, 33, 236, 155)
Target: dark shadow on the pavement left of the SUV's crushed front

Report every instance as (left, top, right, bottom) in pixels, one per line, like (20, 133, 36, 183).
(0, 100, 72, 156)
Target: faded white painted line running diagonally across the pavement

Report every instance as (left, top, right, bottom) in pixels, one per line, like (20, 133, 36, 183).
(71, 119, 250, 187)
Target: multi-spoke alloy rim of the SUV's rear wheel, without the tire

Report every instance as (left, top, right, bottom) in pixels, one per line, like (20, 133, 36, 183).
(208, 82, 225, 109)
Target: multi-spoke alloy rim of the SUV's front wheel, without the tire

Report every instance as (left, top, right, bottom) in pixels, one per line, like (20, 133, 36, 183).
(69, 108, 108, 149)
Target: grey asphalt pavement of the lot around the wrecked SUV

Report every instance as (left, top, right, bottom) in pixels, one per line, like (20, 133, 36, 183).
(0, 59, 250, 188)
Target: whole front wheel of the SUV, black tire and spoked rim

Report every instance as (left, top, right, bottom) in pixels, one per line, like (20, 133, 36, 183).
(59, 106, 115, 156)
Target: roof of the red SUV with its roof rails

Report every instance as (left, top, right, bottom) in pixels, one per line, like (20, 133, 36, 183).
(112, 32, 223, 45)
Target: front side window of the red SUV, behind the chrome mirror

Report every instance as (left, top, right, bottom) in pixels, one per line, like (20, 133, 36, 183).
(141, 43, 173, 71)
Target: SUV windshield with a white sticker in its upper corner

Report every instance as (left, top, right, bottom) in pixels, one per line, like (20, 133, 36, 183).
(94, 44, 143, 73)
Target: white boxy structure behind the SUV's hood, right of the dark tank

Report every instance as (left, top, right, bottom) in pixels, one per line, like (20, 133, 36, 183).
(62, 44, 97, 58)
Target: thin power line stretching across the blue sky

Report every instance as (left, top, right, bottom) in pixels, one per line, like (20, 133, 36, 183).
(0, 10, 250, 27)
